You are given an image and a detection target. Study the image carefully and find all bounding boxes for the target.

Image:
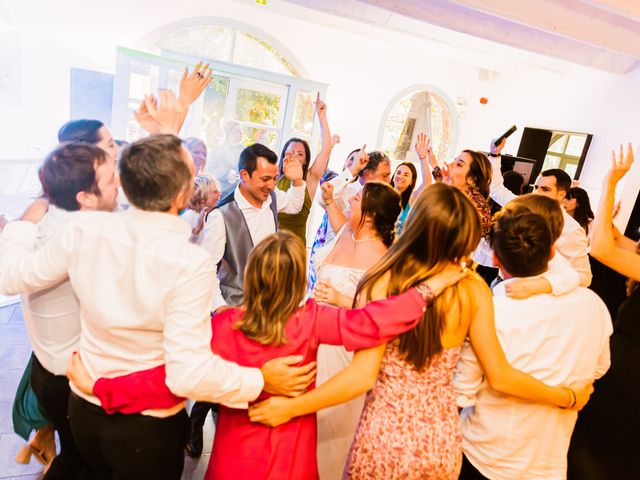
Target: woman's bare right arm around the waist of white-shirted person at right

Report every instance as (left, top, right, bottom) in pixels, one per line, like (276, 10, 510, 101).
(469, 280, 593, 410)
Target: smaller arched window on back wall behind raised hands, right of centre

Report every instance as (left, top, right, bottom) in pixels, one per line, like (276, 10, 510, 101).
(378, 86, 458, 171)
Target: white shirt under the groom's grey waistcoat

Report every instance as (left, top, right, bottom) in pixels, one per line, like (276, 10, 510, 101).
(201, 182, 307, 311)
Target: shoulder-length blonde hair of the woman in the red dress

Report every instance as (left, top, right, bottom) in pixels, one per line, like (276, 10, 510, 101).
(237, 231, 307, 345)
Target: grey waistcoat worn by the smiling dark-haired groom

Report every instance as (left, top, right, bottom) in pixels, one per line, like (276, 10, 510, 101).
(218, 191, 278, 306)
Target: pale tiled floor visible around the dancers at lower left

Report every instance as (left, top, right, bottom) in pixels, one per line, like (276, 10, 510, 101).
(0, 304, 213, 480)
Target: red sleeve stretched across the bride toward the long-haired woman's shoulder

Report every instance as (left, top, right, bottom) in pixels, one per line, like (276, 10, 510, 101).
(308, 288, 427, 350)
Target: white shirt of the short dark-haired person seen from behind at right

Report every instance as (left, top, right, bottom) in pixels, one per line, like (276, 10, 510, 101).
(455, 280, 612, 480)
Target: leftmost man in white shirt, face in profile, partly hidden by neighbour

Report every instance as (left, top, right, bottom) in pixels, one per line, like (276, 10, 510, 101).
(22, 143, 120, 479)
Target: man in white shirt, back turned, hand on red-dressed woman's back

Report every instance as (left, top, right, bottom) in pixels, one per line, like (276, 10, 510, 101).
(0, 135, 314, 479)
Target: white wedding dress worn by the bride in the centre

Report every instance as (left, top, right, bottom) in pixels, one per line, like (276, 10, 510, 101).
(316, 227, 365, 480)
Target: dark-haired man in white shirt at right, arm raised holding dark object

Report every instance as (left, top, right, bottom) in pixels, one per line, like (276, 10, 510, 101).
(489, 139, 592, 287)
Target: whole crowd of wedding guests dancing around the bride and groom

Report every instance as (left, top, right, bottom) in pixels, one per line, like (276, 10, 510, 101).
(0, 64, 640, 480)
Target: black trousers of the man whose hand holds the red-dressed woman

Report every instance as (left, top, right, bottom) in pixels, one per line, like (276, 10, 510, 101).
(69, 393, 189, 480)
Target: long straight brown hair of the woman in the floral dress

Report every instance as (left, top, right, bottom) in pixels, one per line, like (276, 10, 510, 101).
(356, 182, 481, 370)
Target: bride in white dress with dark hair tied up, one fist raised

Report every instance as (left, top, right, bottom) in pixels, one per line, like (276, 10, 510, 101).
(312, 182, 401, 480)
